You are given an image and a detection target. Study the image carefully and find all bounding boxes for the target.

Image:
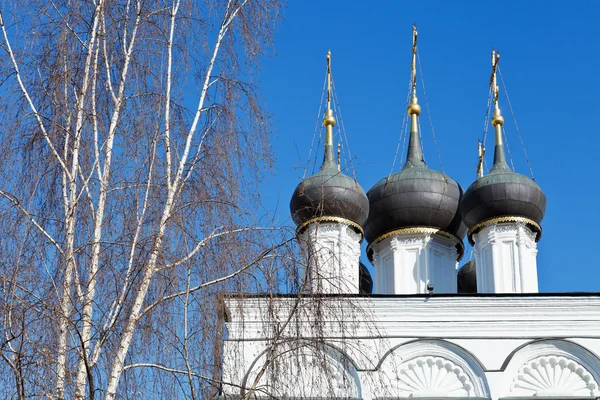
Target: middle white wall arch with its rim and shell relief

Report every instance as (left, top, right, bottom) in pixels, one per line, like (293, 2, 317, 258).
(377, 340, 490, 398)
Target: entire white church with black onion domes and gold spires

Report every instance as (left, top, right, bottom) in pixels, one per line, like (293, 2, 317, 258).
(221, 29, 600, 400)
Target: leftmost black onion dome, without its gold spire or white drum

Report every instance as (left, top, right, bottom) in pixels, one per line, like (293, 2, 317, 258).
(290, 140, 369, 227)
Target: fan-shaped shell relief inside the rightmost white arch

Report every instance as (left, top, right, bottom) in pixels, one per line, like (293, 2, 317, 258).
(510, 356, 600, 397)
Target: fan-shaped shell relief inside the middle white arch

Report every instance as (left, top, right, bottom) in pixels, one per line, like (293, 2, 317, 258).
(391, 356, 473, 397)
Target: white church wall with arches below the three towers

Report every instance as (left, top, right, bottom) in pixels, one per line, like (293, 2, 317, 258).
(223, 296, 600, 400)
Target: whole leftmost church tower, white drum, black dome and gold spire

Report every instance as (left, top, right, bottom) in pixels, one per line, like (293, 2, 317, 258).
(290, 53, 369, 294)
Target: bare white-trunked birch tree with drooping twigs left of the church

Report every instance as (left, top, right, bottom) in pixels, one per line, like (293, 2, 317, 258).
(0, 0, 289, 399)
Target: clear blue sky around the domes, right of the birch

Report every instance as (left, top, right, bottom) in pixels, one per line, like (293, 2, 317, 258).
(259, 0, 600, 292)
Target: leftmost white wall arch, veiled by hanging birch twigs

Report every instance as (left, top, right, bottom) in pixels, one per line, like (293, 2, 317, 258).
(242, 340, 362, 399)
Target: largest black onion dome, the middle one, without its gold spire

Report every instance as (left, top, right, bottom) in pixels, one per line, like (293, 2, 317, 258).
(365, 119, 466, 243)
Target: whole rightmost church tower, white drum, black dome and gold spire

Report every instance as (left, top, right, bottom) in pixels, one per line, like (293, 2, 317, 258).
(460, 52, 546, 293)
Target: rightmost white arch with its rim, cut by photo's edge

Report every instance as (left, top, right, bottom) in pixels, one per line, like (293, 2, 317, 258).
(503, 340, 600, 397)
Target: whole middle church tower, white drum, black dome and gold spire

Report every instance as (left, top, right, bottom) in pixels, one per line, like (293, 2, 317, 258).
(365, 27, 466, 294)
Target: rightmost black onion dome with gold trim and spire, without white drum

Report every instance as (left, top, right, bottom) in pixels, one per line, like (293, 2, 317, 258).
(460, 52, 546, 244)
